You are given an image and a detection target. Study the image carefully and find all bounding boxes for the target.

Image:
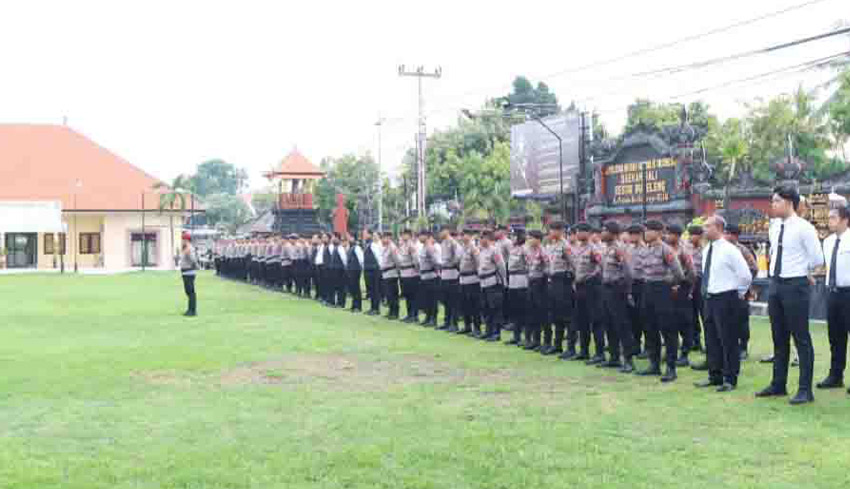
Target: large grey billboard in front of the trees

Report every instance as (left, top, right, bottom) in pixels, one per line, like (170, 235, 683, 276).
(511, 112, 580, 197)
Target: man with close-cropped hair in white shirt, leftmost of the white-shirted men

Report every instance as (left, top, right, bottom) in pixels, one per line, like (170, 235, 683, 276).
(696, 216, 752, 392)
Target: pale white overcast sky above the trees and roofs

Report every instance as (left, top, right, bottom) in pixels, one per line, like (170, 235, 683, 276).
(0, 0, 850, 188)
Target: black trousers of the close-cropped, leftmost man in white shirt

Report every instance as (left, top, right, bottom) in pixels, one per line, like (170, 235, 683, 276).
(705, 290, 741, 385)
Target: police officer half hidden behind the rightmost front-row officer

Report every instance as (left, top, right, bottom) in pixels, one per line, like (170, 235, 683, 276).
(667, 224, 696, 367)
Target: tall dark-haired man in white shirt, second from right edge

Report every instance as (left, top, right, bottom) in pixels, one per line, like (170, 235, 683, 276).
(756, 186, 824, 404)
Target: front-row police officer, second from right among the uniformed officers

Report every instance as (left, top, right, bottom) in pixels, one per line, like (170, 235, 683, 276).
(599, 221, 635, 374)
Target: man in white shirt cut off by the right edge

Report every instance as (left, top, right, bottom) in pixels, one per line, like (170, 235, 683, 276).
(818, 207, 850, 393)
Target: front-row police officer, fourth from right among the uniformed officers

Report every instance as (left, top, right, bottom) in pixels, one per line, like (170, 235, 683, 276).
(540, 222, 568, 359)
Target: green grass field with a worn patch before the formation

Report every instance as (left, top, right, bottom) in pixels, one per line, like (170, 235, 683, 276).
(0, 273, 850, 489)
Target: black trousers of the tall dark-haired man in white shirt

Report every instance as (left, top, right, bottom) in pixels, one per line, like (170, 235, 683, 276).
(767, 277, 815, 391)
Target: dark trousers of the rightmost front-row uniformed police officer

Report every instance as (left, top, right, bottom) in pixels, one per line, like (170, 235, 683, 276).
(641, 282, 679, 369)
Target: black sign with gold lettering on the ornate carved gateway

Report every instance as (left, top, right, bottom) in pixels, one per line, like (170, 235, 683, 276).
(602, 158, 678, 205)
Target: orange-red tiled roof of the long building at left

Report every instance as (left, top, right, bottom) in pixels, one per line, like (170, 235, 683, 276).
(0, 124, 175, 211)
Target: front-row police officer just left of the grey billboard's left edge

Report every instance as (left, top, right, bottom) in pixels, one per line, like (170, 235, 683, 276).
(478, 231, 507, 341)
